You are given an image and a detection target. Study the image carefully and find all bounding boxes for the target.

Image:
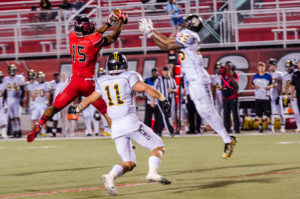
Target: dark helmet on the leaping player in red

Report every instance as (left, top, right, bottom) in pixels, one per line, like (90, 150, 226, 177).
(74, 16, 95, 36)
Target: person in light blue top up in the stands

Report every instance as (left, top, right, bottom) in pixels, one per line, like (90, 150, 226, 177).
(167, 0, 184, 38)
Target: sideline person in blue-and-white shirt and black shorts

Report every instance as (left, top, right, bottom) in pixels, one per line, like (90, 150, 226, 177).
(252, 62, 273, 133)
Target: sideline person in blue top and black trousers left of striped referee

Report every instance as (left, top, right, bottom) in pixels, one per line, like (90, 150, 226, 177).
(144, 68, 159, 127)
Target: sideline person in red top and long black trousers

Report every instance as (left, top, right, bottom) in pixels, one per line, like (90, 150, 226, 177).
(221, 61, 240, 133)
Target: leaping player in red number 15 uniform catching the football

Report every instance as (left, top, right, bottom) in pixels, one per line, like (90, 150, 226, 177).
(27, 10, 128, 142)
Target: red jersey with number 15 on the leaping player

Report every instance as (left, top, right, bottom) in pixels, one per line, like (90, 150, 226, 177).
(69, 32, 104, 77)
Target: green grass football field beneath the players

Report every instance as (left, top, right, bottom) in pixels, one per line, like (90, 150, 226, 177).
(0, 134, 300, 199)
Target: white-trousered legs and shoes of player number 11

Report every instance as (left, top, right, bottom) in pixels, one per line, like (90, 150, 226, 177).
(102, 123, 171, 196)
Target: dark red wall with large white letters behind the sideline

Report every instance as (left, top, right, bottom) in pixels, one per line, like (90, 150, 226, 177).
(0, 48, 300, 91)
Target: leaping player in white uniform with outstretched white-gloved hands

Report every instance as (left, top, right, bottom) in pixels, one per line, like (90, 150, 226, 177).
(139, 14, 237, 159)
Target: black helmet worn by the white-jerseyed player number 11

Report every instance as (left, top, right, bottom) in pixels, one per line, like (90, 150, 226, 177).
(106, 52, 128, 74)
